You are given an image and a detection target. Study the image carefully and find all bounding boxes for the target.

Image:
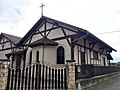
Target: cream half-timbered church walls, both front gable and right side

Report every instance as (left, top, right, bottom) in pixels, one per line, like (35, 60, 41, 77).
(19, 17, 111, 66)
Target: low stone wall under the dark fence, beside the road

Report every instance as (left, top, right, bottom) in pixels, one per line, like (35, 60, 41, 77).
(76, 72, 120, 90)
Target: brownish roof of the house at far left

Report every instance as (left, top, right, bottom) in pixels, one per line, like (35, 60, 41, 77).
(0, 33, 21, 44)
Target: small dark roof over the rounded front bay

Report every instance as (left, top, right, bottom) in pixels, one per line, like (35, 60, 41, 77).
(28, 38, 58, 47)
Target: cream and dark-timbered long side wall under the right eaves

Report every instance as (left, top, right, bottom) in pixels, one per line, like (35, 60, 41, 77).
(74, 39, 108, 66)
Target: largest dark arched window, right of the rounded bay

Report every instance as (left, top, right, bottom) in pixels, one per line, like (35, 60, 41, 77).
(57, 46, 65, 64)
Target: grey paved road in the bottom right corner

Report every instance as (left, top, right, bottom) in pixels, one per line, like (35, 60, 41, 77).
(84, 75, 120, 90)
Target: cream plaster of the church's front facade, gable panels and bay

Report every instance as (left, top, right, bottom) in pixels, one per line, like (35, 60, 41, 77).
(25, 23, 72, 64)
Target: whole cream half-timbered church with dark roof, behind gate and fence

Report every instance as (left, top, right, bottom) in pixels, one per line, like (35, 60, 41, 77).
(0, 16, 116, 67)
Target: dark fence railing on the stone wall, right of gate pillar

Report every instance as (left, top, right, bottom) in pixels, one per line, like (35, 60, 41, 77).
(75, 65, 120, 79)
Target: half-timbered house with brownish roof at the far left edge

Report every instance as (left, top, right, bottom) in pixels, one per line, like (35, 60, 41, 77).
(0, 33, 21, 59)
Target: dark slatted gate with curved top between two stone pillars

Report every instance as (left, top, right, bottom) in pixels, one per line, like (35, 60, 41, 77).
(6, 63, 67, 90)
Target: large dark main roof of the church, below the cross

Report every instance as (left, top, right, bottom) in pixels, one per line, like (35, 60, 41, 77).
(18, 16, 116, 51)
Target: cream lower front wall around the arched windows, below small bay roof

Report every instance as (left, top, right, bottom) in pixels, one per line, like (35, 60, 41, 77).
(26, 39, 71, 65)
